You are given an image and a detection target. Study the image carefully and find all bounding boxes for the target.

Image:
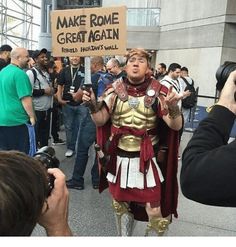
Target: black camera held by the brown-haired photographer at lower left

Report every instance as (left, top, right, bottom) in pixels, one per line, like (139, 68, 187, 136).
(34, 146, 60, 196)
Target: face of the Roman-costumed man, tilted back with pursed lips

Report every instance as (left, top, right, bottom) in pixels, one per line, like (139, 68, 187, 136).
(126, 55, 149, 84)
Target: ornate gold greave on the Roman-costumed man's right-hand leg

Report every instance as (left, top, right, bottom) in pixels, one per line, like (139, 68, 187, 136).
(145, 216, 170, 236)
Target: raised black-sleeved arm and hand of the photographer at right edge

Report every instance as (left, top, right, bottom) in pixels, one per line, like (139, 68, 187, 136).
(180, 70, 236, 207)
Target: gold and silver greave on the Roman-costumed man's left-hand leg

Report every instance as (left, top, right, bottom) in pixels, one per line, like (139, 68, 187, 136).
(112, 199, 134, 236)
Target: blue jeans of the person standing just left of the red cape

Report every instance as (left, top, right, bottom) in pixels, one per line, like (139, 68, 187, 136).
(72, 113, 99, 185)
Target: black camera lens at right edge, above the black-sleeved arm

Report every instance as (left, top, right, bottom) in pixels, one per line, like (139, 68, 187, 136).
(216, 61, 236, 91)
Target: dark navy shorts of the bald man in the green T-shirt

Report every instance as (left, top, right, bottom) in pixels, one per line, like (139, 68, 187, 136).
(0, 124, 29, 154)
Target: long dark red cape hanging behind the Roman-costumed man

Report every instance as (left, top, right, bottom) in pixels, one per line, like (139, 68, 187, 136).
(97, 120, 179, 221)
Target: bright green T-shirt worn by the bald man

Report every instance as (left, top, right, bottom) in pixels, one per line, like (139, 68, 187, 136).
(0, 64, 32, 126)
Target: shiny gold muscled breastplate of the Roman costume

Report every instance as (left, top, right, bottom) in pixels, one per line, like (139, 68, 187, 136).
(112, 96, 158, 152)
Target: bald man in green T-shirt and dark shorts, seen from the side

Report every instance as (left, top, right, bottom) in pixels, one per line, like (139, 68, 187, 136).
(0, 47, 36, 154)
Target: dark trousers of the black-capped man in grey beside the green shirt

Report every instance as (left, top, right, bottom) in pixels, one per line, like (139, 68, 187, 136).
(35, 109, 51, 148)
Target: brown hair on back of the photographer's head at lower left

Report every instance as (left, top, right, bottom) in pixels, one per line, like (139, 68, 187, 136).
(0, 151, 48, 236)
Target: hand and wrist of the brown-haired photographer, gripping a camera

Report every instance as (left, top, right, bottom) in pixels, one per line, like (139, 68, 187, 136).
(38, 168, 72, 236)
